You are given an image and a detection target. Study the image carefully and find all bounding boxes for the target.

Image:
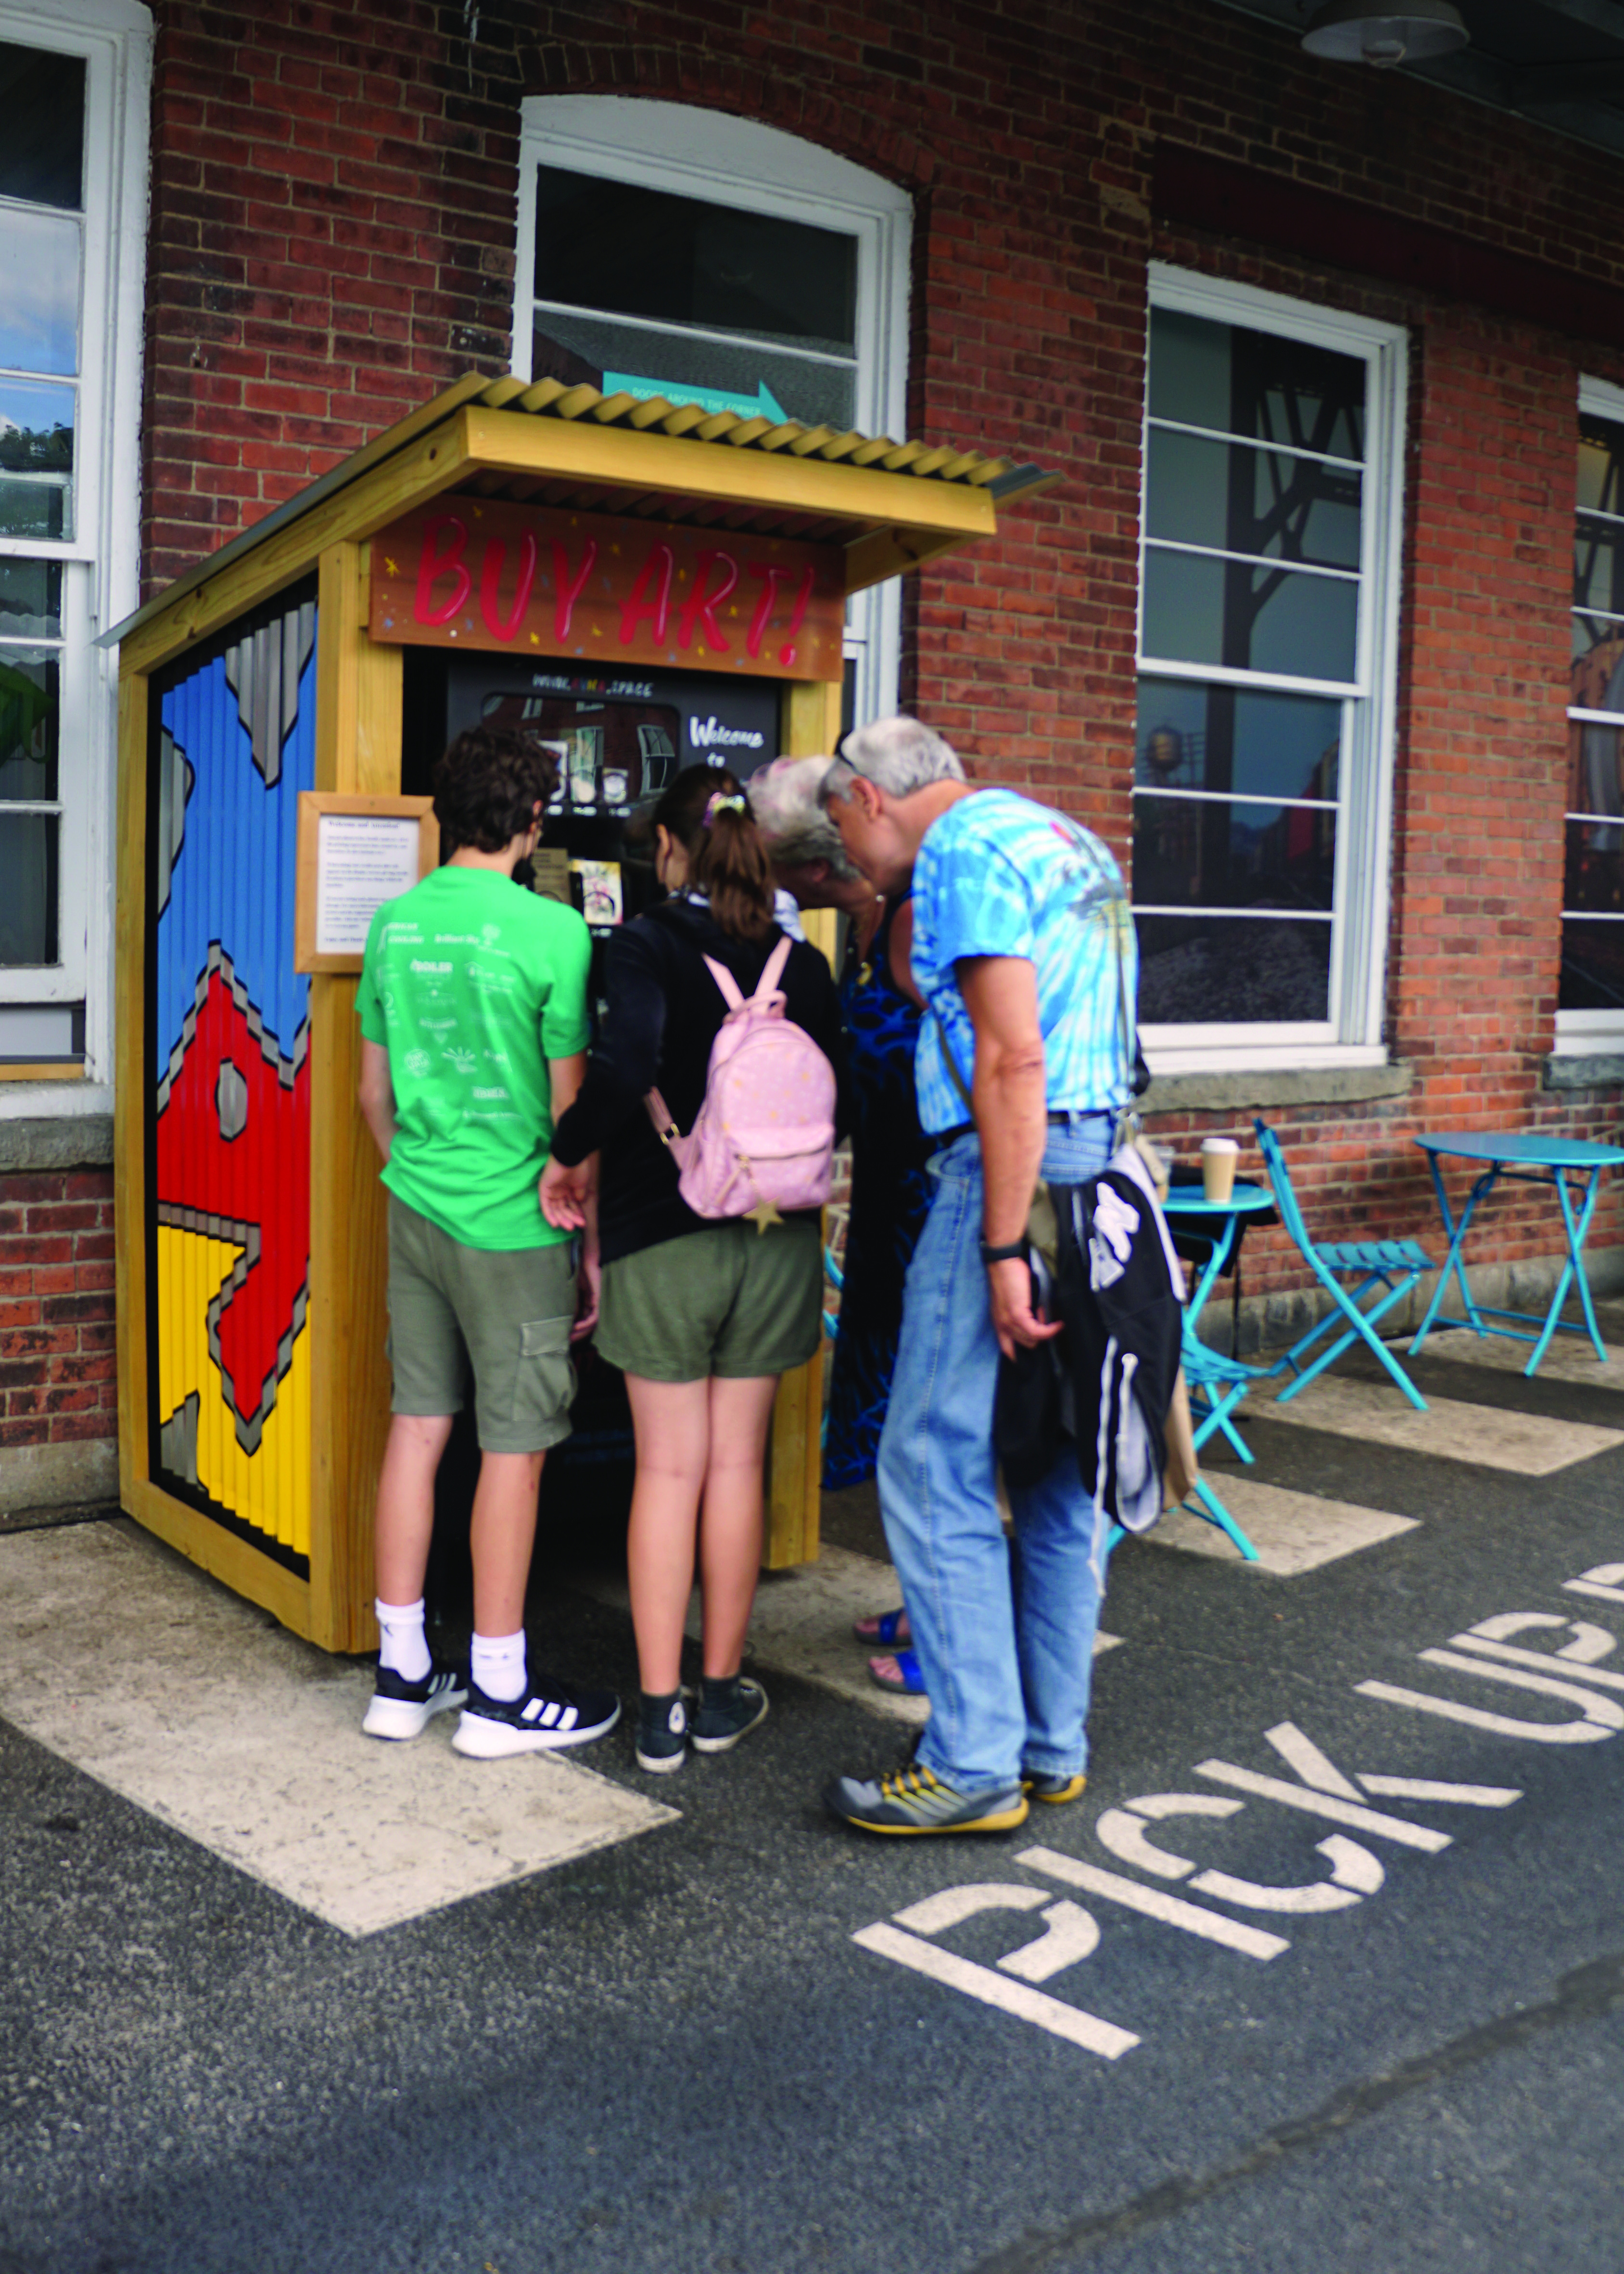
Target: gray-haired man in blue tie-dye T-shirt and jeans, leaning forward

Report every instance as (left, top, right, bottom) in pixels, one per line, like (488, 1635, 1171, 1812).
(824, 718, 1135, 1833)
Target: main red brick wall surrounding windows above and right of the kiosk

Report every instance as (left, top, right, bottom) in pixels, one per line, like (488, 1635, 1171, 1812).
(129, 0, 1624, 1319)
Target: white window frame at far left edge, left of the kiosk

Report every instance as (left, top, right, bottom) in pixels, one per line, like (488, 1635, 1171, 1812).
(0, 0, 152, 1119)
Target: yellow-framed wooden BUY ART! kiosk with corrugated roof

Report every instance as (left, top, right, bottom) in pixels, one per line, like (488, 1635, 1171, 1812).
(109, 378, 1046, 1651)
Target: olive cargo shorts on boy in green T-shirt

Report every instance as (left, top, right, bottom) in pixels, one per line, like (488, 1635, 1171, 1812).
(389, 1191, 575, 1453)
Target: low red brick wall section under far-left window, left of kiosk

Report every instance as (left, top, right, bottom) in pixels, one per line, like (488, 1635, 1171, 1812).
(0, 1169, 118, 1451)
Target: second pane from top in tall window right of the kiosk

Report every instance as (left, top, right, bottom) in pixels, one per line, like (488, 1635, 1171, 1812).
(1144, 427, 1360, 569)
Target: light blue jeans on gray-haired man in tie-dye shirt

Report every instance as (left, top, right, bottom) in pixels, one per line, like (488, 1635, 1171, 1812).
(880, 1114, 1112, 1792)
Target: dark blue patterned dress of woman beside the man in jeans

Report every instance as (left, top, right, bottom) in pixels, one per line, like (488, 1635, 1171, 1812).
(824, 896, 930, 1492)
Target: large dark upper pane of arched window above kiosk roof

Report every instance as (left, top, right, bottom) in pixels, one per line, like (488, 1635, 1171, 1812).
(534, 166, 858, 355)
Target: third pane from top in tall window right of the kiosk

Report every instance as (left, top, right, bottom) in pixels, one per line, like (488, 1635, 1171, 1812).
(1144, 550, 1358, 680)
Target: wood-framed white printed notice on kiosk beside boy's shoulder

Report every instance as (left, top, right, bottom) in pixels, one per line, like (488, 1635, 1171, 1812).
(293, 789, 439, 971)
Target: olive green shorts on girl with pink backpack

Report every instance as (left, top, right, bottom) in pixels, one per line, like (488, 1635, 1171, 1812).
(598, 1216, 824, 1382)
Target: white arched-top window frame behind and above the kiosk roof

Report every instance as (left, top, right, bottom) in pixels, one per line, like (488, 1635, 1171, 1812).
(514, 95, 914, 721)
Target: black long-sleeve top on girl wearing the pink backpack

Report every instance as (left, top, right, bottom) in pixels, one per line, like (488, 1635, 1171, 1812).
(553, 900, 850, 1265)
